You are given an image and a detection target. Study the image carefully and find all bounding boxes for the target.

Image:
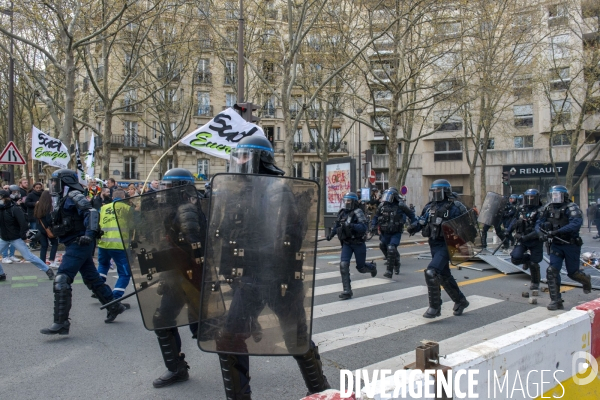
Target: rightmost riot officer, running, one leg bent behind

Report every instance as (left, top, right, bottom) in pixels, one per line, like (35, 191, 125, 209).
(535, 185, 592, 310)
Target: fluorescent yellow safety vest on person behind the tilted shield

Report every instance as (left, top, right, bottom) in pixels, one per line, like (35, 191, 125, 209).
(98, 203, 131, 250)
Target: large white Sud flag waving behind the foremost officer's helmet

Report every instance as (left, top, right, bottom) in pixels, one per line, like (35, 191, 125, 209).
(181, 108, 265, 160)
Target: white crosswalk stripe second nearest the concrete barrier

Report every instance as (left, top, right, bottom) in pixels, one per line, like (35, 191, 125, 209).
(313, 296, 504, 353)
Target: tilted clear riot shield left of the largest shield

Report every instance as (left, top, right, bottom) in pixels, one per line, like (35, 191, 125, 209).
(115, 185, 206, 330)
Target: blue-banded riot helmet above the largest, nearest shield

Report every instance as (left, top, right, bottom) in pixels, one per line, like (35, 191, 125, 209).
(229, 135, 284, 175)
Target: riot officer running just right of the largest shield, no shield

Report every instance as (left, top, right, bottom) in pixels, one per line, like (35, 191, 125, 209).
(327, 192, 377, 300)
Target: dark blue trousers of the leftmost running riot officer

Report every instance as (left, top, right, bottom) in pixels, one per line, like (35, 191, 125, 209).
(59, 241, 113, 301)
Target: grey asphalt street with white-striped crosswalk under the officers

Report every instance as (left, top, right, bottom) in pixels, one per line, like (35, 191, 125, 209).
(0, 229, 600, 400)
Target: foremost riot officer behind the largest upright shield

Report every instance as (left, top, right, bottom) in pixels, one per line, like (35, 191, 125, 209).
(213, 135, 330, 400)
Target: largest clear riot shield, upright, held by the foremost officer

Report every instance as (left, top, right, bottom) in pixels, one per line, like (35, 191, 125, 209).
(198, 174, 319, 355)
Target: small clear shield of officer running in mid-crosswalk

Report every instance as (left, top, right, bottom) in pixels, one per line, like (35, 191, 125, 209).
(442, 210, 481, 265)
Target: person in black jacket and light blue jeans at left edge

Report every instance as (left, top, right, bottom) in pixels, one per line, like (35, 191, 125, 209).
(0, 190, 54, 281)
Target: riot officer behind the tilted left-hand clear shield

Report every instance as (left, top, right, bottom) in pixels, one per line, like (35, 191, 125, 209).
(152, 168, 206, 388)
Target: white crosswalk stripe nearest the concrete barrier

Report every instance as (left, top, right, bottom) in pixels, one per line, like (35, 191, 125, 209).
(360, 307, 564, 371)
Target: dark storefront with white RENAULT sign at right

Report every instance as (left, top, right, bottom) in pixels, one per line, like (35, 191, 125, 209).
(502, 161, 600, 208)
